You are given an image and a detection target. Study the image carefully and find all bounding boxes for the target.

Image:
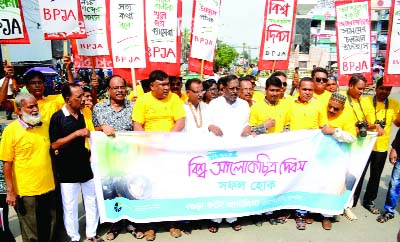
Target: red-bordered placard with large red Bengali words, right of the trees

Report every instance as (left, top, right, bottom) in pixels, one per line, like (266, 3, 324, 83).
(258, 0, 297, 71)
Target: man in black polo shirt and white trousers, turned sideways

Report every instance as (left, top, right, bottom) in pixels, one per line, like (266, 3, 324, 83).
(49, 84, 103, 241)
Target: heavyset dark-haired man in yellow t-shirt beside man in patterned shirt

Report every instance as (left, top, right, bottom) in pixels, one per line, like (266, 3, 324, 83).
(132, 70, 186, 240)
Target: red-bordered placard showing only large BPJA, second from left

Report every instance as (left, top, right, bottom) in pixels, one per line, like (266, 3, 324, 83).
(39, 0, 87, 40)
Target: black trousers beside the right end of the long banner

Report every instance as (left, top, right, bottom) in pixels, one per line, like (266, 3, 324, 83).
(353, 151, 388, 207)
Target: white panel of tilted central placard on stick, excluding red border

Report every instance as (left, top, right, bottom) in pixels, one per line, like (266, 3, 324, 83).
(190, 0, 221, 62)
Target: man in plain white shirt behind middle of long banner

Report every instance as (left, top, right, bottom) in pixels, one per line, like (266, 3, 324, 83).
(208, 75, 251, 233)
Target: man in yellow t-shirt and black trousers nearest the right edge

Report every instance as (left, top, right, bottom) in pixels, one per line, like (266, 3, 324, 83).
(362, 77, 400, 214)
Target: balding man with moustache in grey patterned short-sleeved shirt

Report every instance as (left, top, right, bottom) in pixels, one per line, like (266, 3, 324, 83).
(92, 75, 135, 240)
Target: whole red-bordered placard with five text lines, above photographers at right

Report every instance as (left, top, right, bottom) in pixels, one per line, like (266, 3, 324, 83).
(335, 0, 373, 86)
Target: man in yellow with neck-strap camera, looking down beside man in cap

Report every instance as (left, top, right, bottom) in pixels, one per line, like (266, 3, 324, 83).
(345, 74, 386, 220)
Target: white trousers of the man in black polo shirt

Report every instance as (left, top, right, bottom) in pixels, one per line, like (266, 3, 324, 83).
(60, 179, 99, 241)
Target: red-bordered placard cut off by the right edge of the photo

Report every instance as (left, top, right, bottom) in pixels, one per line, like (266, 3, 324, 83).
(383, 0, 400, 86)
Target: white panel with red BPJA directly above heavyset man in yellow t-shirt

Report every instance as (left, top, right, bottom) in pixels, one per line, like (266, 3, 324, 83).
(146, 0, 180, 63)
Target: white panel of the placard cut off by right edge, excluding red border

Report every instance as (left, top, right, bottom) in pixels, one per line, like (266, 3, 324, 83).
(387, 1, 400, 74)
